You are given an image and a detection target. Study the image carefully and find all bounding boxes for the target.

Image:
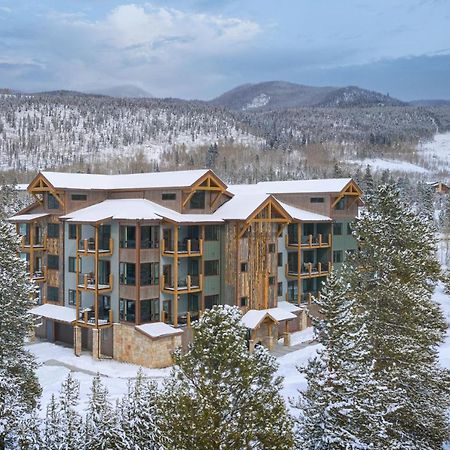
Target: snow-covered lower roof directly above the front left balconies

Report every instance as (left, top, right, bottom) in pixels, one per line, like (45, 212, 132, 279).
(61, 198, 222, 223)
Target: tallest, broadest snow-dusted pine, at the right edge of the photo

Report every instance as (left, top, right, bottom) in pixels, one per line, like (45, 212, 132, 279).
(348, 186, 450, 450)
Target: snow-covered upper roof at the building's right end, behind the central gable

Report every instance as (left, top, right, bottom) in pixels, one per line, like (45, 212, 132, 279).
(256, 178, 352, 194)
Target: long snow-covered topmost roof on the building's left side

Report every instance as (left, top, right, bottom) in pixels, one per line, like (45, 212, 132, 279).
(41, 169, 212, 190)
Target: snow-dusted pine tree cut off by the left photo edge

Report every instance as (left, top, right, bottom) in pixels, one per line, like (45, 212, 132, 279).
(0, 220, 40, 449)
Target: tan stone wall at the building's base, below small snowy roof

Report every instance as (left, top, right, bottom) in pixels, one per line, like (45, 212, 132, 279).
(113, 323, 181, 368)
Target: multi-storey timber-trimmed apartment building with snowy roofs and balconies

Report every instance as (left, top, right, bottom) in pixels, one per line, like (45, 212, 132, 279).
(10, 170, 361, 367)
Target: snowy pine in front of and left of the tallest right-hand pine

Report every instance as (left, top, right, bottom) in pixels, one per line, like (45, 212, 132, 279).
(297, 266, 385, 450)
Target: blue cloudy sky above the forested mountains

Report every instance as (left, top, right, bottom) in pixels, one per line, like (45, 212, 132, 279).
(0, 0, 450, 100)
